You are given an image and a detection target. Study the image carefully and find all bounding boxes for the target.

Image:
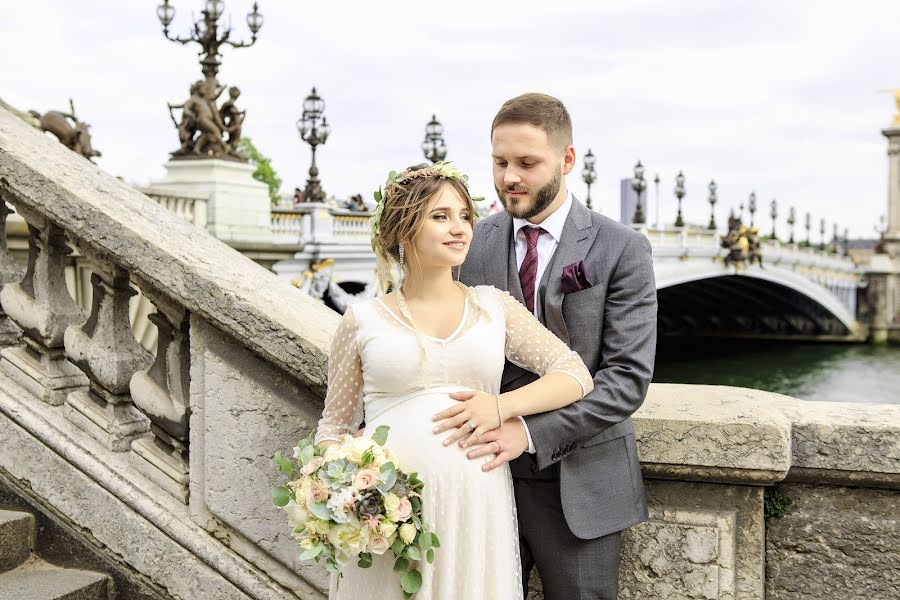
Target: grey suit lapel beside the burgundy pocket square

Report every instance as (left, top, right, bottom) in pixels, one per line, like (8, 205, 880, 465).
(539, 197, 598, 345)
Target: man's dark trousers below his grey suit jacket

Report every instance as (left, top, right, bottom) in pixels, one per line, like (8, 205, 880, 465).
(514, 479, 622, 600)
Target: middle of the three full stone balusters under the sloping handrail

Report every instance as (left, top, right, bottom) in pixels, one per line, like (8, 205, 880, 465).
(65, 257, 153, 452)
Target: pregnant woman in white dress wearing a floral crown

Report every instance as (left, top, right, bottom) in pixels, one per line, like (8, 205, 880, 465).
(315, 163, 593, 600)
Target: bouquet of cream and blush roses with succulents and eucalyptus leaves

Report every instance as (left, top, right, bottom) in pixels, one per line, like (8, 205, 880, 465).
(272, 426, 440, 598)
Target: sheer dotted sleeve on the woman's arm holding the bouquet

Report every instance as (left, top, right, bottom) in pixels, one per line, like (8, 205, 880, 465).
(315, 308, 363, 444)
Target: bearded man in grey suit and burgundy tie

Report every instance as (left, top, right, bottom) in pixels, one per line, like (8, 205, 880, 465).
(457, 94, 656, 600)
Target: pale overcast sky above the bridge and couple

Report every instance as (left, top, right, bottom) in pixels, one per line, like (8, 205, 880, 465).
(0, 0, 900, 237)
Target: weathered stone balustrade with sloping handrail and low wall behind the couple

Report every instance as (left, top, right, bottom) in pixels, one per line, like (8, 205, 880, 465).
(0, 110, 900, 600)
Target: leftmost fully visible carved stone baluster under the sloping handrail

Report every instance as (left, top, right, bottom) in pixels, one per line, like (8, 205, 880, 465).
(0, 207, 88, 405)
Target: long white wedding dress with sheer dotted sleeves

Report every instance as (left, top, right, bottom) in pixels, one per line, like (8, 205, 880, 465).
(315, 286, 593, 600)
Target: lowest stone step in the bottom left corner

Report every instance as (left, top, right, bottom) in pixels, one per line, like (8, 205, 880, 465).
(0, 557, 109, 600)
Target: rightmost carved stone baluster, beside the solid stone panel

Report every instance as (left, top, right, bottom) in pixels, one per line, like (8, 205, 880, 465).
(131, 286, 190, 504)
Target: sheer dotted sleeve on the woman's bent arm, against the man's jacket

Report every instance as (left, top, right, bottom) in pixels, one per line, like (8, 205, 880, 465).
(498, 292, 594, 397)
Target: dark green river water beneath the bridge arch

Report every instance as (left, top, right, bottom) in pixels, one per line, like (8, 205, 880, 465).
(653, 337, 900, 404)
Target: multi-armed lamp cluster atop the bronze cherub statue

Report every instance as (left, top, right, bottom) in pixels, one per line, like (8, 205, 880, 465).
(156, 0, 263, 96)
